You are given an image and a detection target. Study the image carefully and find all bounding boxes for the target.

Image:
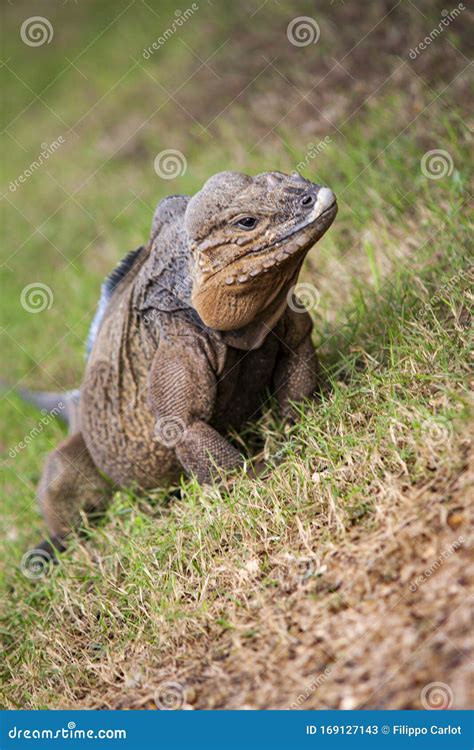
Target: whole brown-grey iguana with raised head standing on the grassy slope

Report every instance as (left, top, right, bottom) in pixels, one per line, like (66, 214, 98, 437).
(17, 172, 337, 560)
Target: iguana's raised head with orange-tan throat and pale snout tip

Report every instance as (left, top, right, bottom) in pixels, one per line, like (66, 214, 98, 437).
(185, 172, 337, 331)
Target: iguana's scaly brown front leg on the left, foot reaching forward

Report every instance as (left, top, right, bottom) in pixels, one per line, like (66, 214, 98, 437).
(149, 336, 243, 483)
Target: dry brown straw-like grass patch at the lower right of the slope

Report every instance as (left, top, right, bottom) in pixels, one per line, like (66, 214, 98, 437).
(51, 424, 466, 709)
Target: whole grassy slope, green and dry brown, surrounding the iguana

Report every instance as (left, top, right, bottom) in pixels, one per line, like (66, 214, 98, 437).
(0, 0, 472, 708)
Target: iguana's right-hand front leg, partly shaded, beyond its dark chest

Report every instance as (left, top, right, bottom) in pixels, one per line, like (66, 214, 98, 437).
(274, 310, 319, 421)
